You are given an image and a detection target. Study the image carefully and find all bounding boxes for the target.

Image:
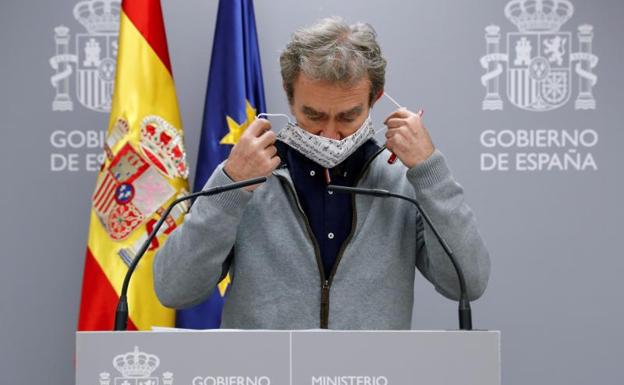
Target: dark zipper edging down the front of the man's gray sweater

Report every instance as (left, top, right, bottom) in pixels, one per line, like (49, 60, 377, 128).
(276, 147, 385, 329)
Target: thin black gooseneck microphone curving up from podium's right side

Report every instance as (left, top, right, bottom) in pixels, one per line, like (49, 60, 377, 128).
(327, 184, 472, 330)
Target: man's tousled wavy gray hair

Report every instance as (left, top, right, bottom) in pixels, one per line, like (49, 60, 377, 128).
(280, 17, 386, 104)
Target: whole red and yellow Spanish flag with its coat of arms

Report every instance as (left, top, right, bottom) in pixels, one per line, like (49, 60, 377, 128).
(78, 0, 188, 330)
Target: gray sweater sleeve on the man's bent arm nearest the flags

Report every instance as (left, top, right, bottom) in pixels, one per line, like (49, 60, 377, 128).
(154, 165, 253, 308)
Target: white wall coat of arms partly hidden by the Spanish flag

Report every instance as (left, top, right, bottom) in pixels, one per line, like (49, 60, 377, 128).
(50, 0, 121, 112)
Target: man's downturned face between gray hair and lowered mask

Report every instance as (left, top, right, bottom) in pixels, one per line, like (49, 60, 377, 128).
(290, 73, 371, 140)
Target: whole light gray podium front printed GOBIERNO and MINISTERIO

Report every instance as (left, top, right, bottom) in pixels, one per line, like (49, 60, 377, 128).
(76, 330, 501, 385)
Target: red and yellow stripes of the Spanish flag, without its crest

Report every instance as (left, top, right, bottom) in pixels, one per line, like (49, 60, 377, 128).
(78, 0, 188, 330)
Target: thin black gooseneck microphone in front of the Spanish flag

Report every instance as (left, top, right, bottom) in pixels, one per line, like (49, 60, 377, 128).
(113, 176, 267, 331)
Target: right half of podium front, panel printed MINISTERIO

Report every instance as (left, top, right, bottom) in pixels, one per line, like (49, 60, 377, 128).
(292, 331, 500, 385)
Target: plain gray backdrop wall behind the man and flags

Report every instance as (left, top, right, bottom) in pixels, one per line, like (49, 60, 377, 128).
(0, 0, 624, 385)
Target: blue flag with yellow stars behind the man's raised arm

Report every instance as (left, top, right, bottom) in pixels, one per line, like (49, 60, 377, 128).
(176, 0, 266, 329)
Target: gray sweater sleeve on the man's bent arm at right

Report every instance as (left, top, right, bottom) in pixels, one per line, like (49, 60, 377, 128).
(407, 150, 490, 300)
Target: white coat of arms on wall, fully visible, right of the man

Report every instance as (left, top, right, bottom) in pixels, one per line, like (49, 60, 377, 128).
(481, 0, 598, 111)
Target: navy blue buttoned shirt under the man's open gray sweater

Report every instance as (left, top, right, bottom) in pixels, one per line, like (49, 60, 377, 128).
(285, 140, 379, 279)
